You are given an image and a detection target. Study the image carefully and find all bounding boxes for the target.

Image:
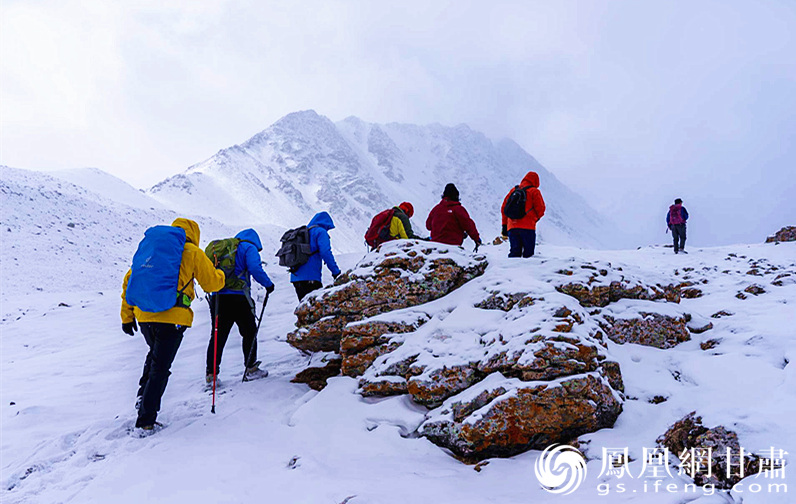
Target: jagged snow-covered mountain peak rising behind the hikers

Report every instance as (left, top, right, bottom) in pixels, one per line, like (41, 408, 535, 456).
(149, 110, 616, 251)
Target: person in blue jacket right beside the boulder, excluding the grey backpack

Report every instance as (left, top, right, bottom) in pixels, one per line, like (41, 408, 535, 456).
(290, 212, 340, 301)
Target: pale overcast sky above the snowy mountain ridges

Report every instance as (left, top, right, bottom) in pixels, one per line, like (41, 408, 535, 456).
(0, 0, 796, 245)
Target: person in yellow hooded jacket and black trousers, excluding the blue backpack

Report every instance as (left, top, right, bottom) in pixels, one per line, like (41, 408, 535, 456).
(121, 218, 224, 430)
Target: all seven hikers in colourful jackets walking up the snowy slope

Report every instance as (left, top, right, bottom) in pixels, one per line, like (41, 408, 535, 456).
(121, 171, 688, 431)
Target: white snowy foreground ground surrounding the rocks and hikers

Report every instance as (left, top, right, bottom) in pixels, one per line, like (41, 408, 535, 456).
(0, 236, 796, 504)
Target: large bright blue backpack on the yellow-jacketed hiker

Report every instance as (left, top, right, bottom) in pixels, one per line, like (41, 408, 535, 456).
(126, 226, 190, 312)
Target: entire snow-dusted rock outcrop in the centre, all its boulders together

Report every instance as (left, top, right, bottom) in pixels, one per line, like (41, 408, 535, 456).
(282, 246, 710, 461)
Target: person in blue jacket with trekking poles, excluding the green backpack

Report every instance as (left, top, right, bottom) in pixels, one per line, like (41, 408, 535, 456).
(205, 229, 274, 383)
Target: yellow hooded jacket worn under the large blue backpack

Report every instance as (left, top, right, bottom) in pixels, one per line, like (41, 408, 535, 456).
(122, 218, 224, 327)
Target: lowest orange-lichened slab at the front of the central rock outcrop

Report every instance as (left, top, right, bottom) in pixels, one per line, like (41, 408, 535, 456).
(420, 373, 622, 460)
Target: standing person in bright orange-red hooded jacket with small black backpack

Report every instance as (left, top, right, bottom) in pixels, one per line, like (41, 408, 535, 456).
(500, 172, 545, 257)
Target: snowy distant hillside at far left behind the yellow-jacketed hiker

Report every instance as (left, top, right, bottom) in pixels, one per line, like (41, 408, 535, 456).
(0, 166, 246, 298)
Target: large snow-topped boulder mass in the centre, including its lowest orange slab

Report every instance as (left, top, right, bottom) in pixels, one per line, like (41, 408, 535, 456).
(356, 262, 636, 460)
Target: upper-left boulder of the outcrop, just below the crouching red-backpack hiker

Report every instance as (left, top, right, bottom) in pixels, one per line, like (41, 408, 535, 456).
(287, 240, 487, 376)
